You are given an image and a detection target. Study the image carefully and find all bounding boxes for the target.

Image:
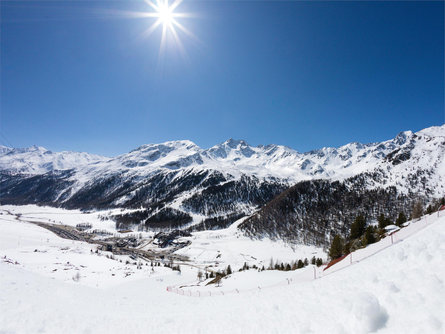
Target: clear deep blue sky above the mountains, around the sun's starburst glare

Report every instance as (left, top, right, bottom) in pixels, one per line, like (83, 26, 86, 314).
(0, 0, 444, 155)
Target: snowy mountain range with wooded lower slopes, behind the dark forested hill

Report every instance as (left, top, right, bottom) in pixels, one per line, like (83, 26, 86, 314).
(0, 125, 445, 244)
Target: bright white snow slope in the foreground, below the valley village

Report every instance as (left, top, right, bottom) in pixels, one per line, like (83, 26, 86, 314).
(0, 207, 445, 334)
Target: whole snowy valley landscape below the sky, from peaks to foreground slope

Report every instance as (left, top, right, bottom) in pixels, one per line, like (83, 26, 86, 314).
(0, 125, 445, 333)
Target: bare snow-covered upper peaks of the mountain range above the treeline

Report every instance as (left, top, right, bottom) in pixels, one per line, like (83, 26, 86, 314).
(0, 125, 445, 182)
